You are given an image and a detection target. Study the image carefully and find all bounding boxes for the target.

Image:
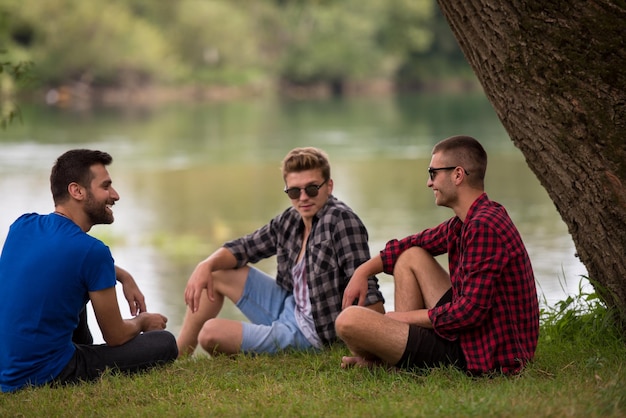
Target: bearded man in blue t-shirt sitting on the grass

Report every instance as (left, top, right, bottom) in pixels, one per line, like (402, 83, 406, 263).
(0, 149, 178, 392)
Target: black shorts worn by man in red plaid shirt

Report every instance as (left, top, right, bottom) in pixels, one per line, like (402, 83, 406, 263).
(396, 289, 467, 370)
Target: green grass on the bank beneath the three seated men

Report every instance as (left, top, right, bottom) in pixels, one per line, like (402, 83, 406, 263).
(0, 282, 626, 417)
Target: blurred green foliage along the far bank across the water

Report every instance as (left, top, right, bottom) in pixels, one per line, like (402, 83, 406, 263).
(0, 0, 471, 91)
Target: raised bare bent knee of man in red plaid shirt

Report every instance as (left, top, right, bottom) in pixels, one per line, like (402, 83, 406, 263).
(393, 247, 451, 312)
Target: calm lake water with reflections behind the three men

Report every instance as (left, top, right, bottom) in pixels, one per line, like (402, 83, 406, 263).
(0, 96, 585, 338)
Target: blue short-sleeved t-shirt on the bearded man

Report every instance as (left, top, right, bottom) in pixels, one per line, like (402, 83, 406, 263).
(0, 213, 115, 392)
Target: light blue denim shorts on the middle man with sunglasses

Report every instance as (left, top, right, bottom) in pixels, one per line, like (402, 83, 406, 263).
(236, 267, 315, 353)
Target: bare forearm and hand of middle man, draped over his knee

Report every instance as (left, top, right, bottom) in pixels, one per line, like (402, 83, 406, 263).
(185, 247, 237, 312)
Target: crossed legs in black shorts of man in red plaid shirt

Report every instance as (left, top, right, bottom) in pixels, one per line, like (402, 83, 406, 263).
(335, 247, 465, 368)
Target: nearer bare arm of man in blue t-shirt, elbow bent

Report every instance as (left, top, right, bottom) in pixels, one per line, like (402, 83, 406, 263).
(89, 287, 167, 346)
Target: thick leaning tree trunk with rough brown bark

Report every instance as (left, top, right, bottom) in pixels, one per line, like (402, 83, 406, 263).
(438, 0, 626, 319)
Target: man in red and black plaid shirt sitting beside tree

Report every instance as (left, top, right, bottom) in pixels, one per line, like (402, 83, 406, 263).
(335, 136, 539, 374)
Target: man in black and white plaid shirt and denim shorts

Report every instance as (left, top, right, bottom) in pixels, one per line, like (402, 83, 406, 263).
(177, 147, 384, 356)
